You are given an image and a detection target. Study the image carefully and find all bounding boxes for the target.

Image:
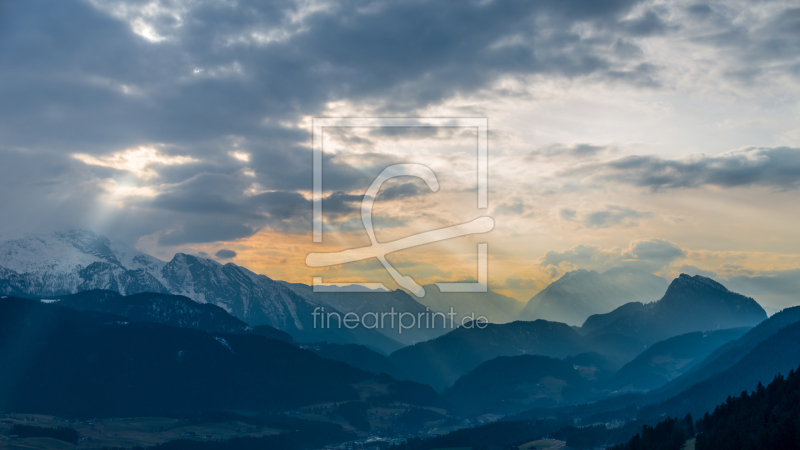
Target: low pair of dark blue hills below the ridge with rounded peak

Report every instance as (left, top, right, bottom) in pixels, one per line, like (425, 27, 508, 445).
(434, 328, 748, 415)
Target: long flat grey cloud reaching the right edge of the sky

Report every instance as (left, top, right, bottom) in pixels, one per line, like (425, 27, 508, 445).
(571, 147, 800, 191)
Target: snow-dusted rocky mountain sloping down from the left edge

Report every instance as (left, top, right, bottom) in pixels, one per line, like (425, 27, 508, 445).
(0, 230, 400, 353)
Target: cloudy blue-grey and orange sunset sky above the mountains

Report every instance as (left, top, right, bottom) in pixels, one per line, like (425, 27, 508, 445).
(0, 0, 800, 308)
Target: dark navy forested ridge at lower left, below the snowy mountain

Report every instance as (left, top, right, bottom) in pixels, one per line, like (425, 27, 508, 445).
(0, 298, 444, 417)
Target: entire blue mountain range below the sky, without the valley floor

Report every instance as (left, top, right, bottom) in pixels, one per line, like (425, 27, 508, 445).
(0, 232, 800, 444)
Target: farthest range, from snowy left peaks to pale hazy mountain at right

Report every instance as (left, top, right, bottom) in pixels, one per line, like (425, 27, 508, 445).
(0, 230, 712, 354)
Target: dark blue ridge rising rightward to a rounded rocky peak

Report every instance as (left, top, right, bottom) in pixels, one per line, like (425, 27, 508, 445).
(390, 275, 767, 390)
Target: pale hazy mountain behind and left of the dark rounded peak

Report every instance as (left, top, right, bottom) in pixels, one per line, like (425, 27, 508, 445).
(519, 267, 667, 325)
